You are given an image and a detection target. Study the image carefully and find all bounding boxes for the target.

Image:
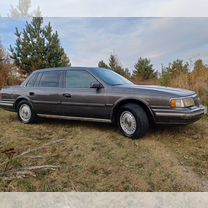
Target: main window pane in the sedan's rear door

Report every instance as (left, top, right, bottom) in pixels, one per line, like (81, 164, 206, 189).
(39, 71, 62, 87)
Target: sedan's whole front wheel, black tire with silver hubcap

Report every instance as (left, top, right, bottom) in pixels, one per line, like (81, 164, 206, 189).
(117, 103, 149, 139)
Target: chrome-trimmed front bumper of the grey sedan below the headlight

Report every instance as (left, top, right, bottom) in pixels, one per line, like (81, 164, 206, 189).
(153, 105, 205, 124)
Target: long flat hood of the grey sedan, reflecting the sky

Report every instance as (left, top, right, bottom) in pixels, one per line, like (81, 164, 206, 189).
(115, 84, 195, 97)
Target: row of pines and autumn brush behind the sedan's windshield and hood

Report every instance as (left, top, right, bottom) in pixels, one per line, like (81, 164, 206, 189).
(98, 54, 208, 105)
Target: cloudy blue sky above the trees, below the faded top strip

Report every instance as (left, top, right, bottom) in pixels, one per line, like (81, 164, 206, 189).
(0, 18, 208, 70)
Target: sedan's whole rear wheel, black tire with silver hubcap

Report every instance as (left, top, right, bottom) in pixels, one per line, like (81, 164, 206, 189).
(17, 100, 37, 124)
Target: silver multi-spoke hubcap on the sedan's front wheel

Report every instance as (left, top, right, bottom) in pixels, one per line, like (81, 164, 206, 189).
(120, 111, 137, 135)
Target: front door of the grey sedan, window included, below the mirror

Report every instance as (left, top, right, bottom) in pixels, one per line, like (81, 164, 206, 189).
(61, 70, 107, 119)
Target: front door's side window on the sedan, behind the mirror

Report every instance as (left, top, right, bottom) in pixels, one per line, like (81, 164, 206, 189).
(66, 70, 99, 88)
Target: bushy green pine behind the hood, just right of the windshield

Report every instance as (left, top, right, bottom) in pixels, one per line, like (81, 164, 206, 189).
(133, 57, 157, 80)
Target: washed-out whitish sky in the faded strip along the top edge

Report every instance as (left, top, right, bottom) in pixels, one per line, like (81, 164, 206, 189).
(0, 0, 208, 17)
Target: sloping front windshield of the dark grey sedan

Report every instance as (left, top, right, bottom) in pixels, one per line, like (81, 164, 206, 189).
(93, 68, 132, 86)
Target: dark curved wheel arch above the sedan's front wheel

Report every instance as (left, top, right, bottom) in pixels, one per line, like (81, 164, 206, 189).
(111, 98, 155, 124)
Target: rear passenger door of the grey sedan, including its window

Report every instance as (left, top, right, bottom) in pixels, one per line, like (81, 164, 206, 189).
(27, 70, 63, 115)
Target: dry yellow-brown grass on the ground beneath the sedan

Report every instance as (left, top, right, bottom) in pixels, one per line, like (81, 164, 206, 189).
(0, 111, 208, 191)
